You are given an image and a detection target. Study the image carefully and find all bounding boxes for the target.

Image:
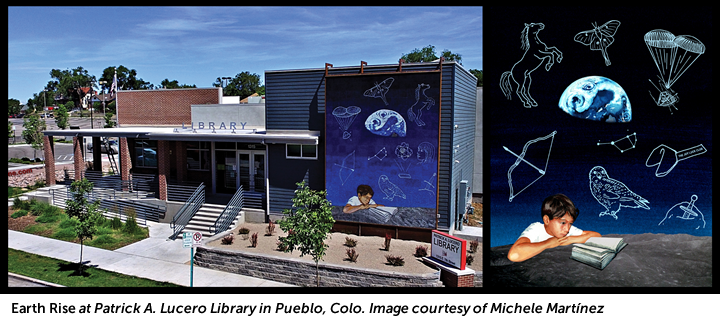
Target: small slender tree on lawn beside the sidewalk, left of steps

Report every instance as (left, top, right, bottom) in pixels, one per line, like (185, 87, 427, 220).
(65, 178, 103, 275)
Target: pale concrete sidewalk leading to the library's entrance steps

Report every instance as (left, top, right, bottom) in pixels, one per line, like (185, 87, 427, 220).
(8, 222, 291, 287)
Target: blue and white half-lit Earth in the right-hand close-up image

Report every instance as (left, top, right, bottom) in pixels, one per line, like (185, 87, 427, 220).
(559, 76, 632, 123)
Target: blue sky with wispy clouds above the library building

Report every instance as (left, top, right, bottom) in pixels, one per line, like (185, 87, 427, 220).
(8, 7, 483, 103)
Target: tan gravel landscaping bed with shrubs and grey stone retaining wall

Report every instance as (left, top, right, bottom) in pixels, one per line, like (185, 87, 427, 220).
(195, 223, 482, 286)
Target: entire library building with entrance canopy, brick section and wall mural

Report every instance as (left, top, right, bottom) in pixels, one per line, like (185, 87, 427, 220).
(38, 60, 482, 286)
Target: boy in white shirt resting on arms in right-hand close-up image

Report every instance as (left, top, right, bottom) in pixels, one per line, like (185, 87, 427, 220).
(508, 194, 600, 262)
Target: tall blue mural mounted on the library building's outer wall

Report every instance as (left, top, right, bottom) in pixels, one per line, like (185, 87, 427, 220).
(325, 72, 441, 228)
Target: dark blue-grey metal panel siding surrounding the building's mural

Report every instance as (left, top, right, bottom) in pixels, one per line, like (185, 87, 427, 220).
(265, 62, 477, 230)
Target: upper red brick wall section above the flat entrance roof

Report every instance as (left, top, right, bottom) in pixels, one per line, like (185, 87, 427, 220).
(117, 88, 222, 127)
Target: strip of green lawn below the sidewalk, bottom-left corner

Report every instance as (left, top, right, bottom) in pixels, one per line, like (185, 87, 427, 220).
(8, 248, 180, 287)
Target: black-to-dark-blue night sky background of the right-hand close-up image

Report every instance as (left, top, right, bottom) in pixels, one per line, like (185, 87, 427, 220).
(484, 6, 717, 247)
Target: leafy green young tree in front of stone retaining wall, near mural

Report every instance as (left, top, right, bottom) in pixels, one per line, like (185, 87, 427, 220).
(279, 181, 335, 286)
